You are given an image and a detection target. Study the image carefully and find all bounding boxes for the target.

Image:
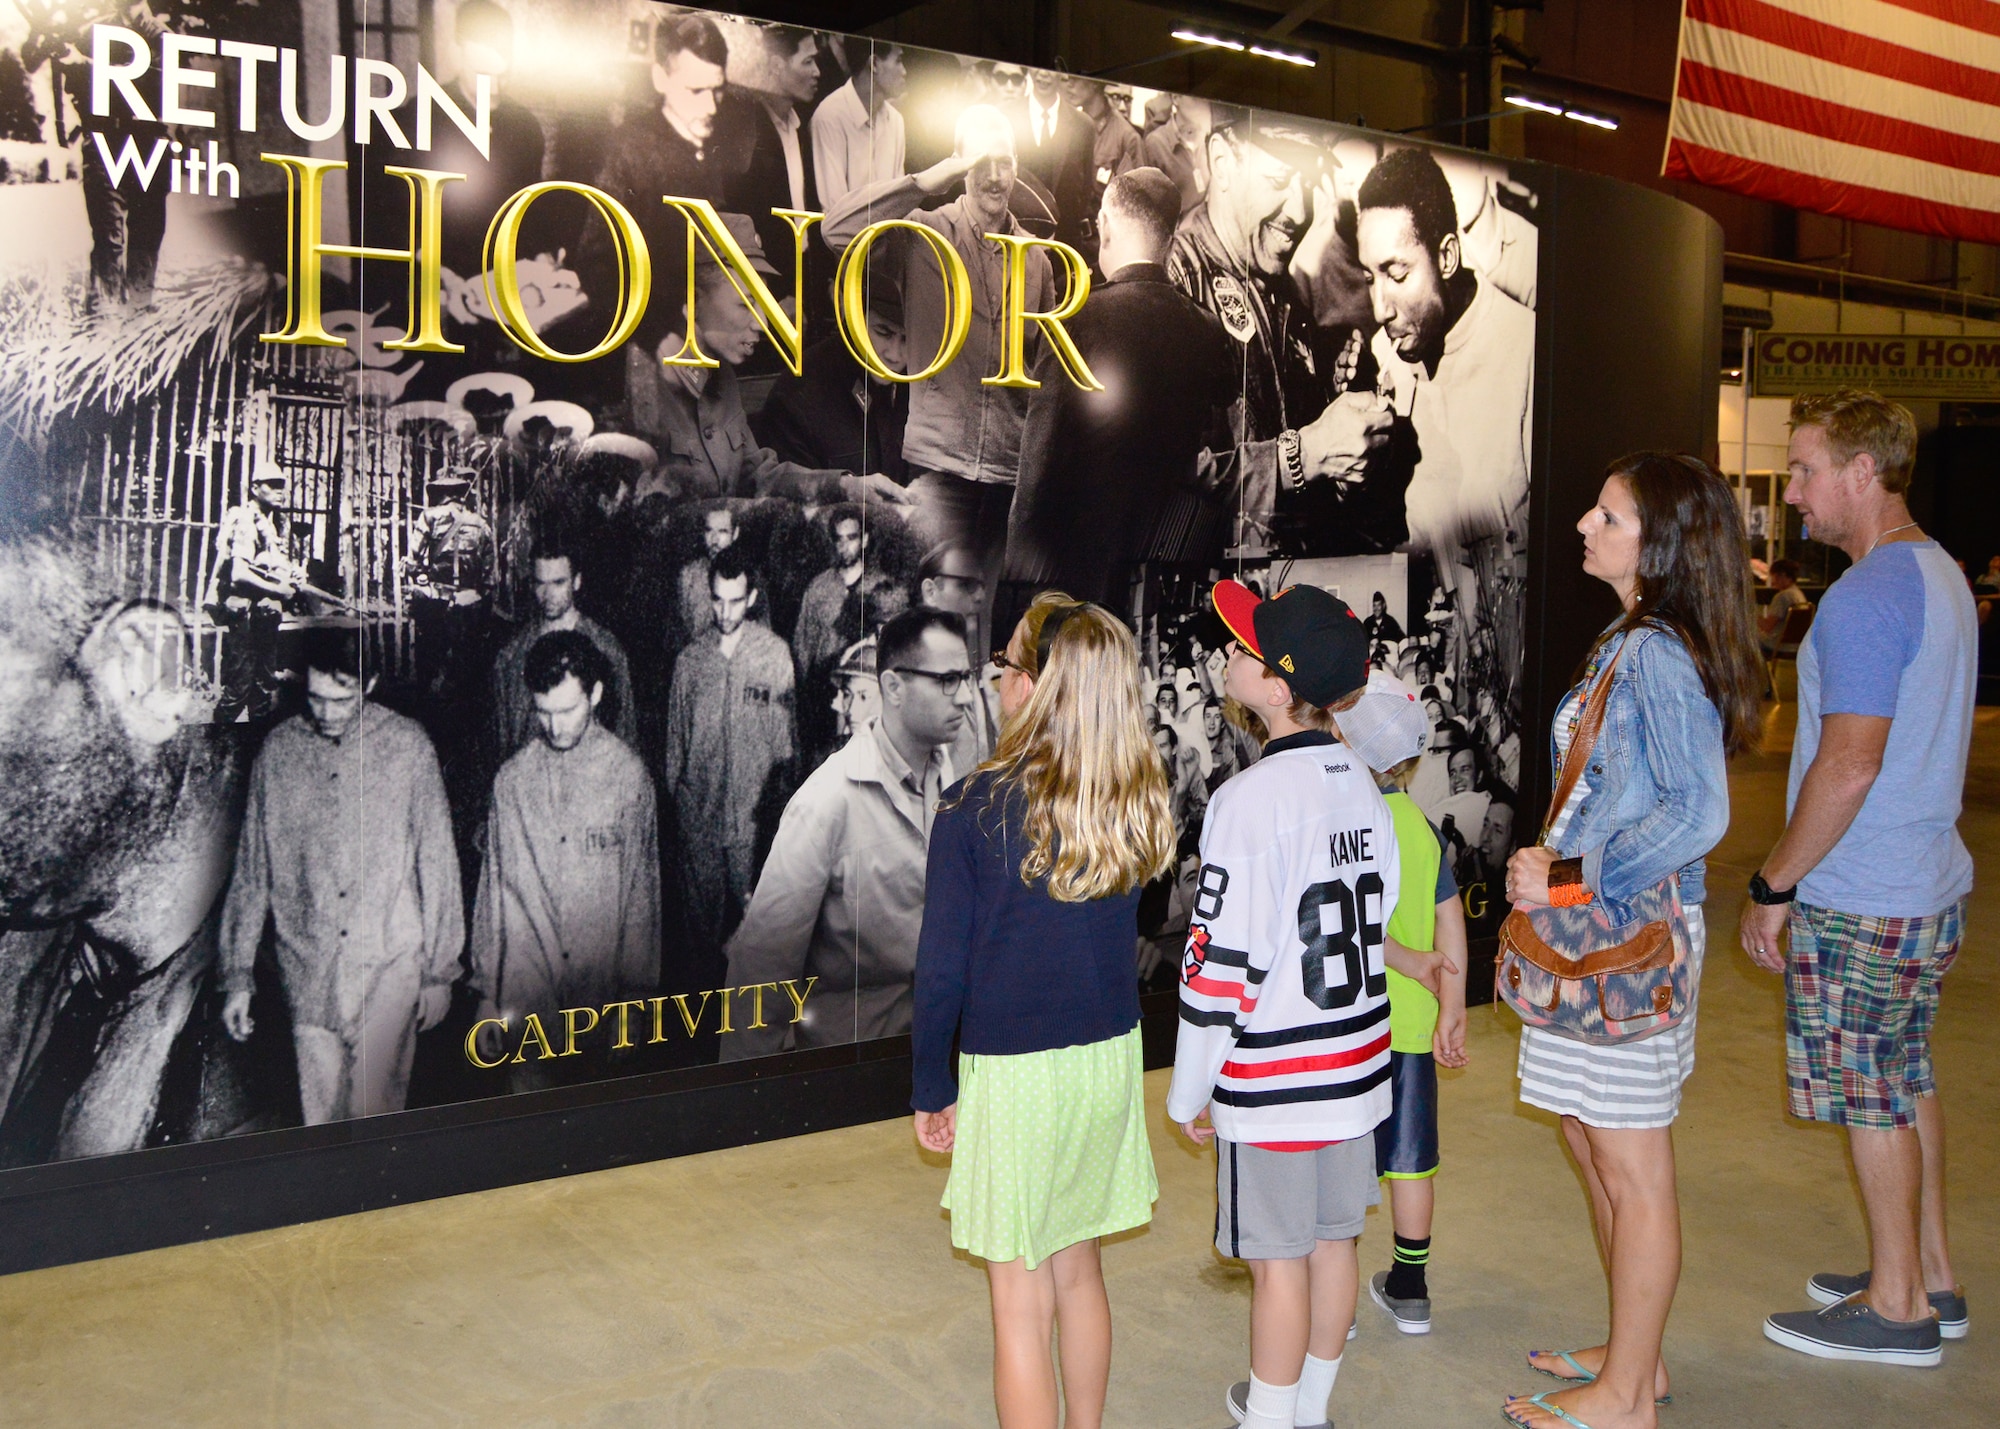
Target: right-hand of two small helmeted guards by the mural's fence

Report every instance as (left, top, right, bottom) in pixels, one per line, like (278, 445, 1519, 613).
(410, 466, 494, 694)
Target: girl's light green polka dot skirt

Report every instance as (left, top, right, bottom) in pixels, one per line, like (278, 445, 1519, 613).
(940, 1027, 1160, 1271)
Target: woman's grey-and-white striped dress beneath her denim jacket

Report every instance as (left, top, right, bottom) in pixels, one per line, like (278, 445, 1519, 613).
(1518, 686, 1708, 1131)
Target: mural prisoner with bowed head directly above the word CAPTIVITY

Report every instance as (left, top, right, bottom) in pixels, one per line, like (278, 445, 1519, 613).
(470, 630, 660, 1091)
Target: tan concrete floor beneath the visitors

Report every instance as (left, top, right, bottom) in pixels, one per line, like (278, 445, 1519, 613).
(0, 710, 2000, 1429)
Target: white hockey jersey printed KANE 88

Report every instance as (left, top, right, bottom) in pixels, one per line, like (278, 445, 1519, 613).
(1166, 735, 1398, 1145)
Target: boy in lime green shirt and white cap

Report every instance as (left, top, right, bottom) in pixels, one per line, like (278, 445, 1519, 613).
(1340, 670, 1466, 1335)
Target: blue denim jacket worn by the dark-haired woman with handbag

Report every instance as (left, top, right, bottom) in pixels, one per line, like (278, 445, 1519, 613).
(1550, 626, 1730, 925)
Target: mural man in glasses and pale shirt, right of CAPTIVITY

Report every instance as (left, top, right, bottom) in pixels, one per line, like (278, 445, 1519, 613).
(722, 606, 978, 1061)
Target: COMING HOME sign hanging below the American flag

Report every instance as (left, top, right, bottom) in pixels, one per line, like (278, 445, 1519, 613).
(1752, 332, 2000, 402)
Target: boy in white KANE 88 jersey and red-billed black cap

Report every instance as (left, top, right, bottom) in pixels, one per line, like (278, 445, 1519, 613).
(1166, 580, 1456, 1429)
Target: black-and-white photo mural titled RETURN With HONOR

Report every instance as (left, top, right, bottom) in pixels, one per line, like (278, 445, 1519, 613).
(0, 0, 1538, 1165)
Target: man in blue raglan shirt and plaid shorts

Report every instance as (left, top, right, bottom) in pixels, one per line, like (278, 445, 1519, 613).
(1742, 390, 1978, 1365)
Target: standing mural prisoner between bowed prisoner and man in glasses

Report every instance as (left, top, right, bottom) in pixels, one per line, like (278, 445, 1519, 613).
(660, 546, 798, 968)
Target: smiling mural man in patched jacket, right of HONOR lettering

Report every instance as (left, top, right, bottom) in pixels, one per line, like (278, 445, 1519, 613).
(1168, 106, 1408, 554)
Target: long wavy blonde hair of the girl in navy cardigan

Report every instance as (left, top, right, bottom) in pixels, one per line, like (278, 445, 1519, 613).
(980, 590, 1174, 903)
